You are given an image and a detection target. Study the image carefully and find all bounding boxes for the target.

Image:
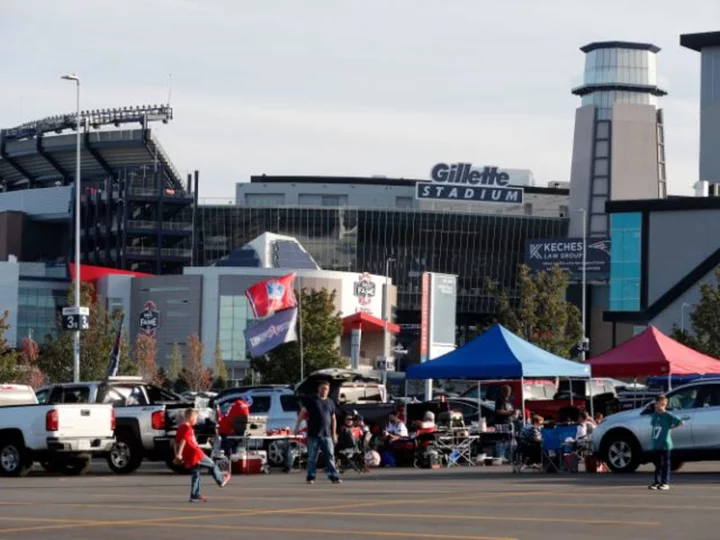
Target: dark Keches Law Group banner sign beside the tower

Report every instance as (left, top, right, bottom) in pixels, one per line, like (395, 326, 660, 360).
(525, 238, 610, 280)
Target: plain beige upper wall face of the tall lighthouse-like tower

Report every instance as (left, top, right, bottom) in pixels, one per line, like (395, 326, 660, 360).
(610, 103, 660, 200)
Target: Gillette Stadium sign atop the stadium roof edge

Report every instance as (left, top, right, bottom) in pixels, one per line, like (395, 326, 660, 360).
(415, 163, 524, 204)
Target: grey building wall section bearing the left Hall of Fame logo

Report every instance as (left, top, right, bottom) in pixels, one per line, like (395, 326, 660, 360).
(128, 276, 201, 366)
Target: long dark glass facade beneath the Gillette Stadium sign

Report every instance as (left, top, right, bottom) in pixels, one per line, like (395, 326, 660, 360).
(198, 206, 568, 318)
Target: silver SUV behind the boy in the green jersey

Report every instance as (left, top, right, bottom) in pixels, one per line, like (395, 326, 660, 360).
(592, 379, 720, 472)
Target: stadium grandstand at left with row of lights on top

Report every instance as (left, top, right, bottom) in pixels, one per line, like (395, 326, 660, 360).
(0, 105, 198, 274)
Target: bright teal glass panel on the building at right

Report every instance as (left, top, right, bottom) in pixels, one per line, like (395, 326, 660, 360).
(610, 212, 642, 311)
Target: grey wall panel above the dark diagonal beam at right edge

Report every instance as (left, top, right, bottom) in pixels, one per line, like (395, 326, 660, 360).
(648, 210, 720, 305)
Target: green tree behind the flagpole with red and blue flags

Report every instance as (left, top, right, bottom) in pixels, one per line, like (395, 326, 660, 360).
(252, 289, 345, 384)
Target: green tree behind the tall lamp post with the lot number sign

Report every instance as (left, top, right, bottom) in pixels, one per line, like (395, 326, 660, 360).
(38, 283, 134, 382)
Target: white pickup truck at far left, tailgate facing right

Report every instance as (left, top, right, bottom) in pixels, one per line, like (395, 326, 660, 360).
(0, 384, 115, 476)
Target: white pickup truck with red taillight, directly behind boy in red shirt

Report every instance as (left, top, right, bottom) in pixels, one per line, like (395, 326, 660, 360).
(38, 377, 215, 474)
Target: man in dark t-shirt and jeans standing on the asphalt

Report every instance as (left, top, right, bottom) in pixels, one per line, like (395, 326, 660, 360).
(295, 381, 341, 484)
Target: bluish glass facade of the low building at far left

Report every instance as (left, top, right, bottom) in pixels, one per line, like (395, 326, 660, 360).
(17, 282, 68, 343)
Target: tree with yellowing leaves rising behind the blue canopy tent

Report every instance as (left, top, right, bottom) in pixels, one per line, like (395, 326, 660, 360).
(488, 265, 583, 358)
